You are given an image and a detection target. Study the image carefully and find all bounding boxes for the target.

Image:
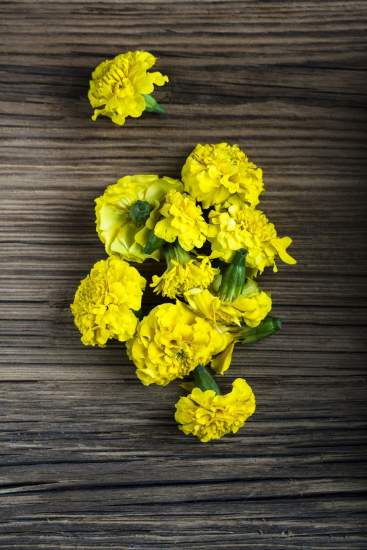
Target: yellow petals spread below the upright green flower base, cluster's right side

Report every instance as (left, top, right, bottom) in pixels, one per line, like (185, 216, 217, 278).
(185, 280, 272, 327)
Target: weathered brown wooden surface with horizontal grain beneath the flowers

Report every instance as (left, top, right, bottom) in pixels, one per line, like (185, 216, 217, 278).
(0, 0, 367, 550)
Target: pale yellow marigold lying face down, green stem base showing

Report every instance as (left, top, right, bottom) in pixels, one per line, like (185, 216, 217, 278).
(96, 174, 182, 262)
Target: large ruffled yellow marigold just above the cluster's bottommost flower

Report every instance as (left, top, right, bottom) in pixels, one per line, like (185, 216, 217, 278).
(127, 302, 231, 386)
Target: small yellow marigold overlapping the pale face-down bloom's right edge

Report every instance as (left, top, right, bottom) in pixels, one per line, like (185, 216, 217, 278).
(154, 191, 208, 250)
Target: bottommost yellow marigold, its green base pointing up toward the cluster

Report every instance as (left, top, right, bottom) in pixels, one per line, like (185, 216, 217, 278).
(175, 378, 256, 443)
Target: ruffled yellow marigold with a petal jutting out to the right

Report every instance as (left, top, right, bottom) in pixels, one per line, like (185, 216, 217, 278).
(208, 198, 296, 274)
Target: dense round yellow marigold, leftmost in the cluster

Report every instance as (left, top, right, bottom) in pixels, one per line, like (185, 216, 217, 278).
(70, 256, 146, 346)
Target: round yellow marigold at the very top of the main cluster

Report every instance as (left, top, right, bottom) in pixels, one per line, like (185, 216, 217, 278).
(182, 143, 264, 208)
